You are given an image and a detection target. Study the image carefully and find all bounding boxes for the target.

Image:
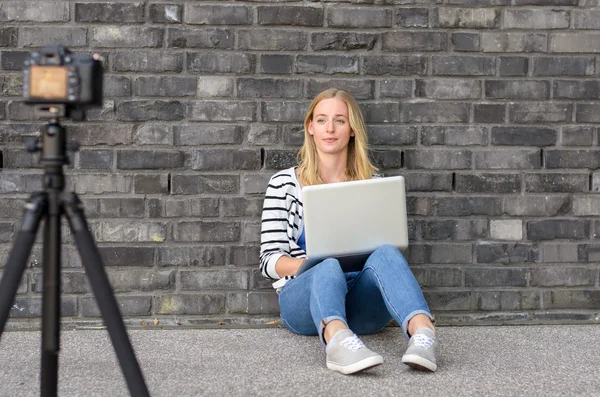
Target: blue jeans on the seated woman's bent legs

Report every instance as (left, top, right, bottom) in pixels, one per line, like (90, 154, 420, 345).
(279, 245, 433, 342)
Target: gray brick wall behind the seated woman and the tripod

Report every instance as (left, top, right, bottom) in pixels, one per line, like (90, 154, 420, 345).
(0, 0, 600, 324)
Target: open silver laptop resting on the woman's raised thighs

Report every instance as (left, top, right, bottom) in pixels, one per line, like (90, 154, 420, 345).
(296, 176, 408, 276)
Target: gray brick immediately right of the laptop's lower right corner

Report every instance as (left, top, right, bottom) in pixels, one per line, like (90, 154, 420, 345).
(406, 243, 472, 264)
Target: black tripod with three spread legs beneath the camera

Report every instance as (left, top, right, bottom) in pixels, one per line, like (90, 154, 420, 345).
(0, 118, 149, 397)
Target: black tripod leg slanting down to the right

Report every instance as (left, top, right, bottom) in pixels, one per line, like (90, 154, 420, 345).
(64, 193, 149, 397)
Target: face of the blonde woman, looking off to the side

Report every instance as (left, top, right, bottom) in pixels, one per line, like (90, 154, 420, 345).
(308, 98, 354, 154)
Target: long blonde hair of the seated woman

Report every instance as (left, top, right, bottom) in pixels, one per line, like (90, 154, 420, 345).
(298, 88, 377, 185)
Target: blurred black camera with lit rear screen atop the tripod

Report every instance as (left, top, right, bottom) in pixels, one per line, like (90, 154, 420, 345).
(23, 45, 103, 111)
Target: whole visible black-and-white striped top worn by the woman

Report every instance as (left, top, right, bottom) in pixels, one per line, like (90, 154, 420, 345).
(260, 167, 306, 280)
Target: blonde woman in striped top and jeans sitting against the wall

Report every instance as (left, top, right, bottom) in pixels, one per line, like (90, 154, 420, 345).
(260, 89, 437, 374)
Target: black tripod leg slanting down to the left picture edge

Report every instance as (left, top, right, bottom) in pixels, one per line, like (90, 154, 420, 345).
(0, 193, 47, 337)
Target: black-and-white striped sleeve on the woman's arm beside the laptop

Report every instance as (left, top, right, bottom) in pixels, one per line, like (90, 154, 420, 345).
(260, 173, 294, 280)
